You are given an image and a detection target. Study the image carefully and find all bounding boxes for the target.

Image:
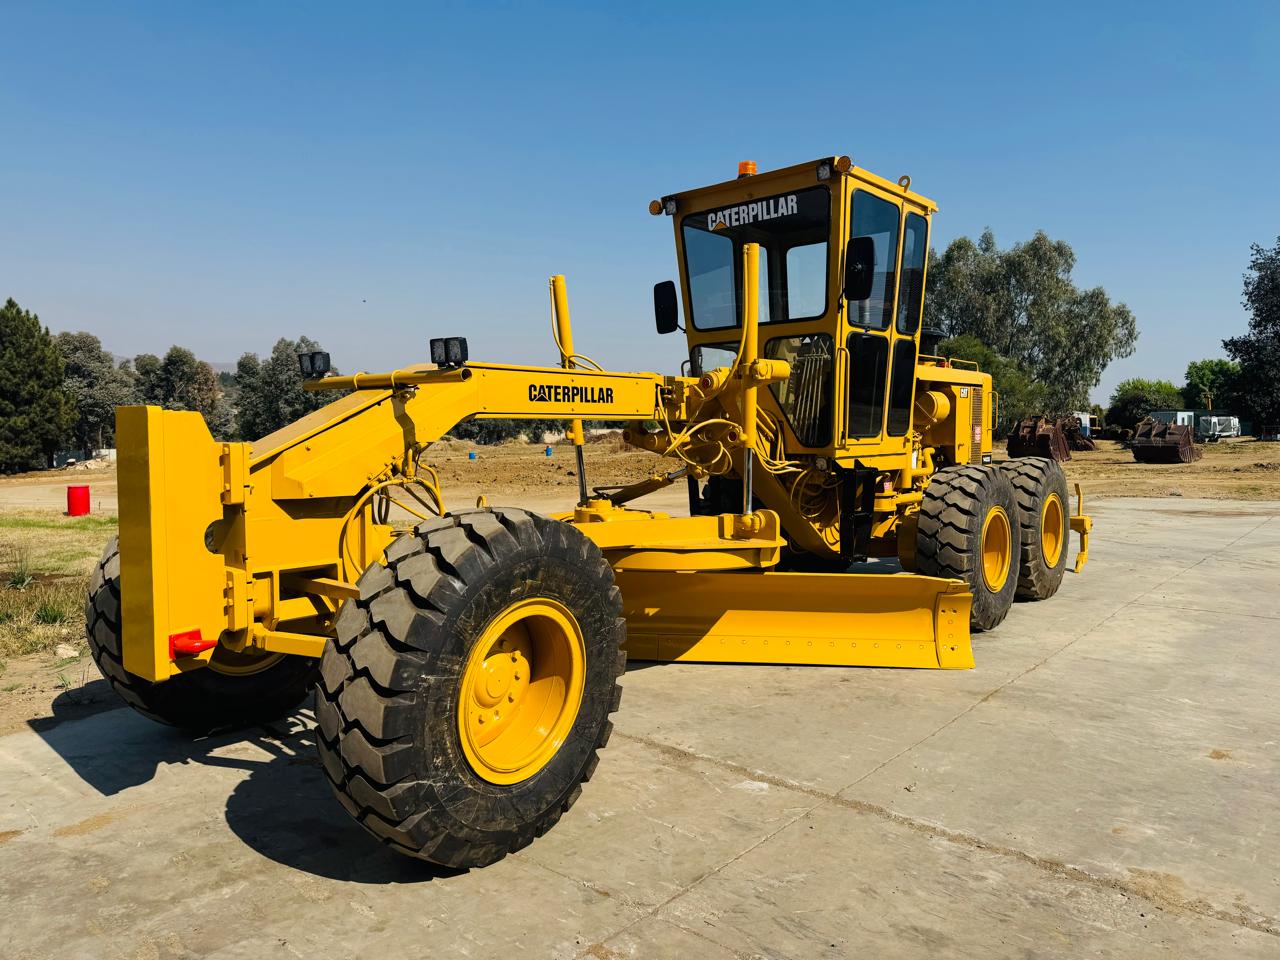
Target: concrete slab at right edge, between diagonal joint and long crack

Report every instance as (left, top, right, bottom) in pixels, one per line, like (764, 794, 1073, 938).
(842, 504, 1280, 924)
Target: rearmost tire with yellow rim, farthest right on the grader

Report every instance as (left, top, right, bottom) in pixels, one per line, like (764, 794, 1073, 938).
(1000, 457, 1070, 600)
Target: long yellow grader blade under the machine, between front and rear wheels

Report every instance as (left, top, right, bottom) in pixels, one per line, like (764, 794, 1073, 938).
(617, 571, 973, 669)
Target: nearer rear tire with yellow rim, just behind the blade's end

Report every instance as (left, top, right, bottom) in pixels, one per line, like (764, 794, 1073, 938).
(915, 466, 1020, 630)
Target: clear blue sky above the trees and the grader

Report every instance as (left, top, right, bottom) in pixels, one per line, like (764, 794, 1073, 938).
(0, 1, 1280, 398)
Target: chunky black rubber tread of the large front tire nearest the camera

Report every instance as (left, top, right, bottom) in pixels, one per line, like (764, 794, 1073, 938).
(316, 508, 626, 868)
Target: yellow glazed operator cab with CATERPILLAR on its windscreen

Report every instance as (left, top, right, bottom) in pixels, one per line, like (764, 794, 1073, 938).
(650, 157, 937, 461)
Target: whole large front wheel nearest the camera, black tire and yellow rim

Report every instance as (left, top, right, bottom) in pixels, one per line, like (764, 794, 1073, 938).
(316, 509, 626, 868)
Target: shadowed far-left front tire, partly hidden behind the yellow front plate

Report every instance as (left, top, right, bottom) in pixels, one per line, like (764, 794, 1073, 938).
(84, 536, 317, 733)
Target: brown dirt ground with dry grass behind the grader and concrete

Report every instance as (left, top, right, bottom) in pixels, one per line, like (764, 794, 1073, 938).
(0, 435, 1280, 733)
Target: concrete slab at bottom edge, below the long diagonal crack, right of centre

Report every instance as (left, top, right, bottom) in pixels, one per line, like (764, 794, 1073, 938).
(650, 804, 1276, 960)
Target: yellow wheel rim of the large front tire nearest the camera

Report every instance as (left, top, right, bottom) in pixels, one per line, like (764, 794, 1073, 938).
(458, 598, 586, 783)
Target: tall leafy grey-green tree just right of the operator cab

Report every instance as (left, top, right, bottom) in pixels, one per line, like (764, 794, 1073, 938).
(925, 230, 1138, 411)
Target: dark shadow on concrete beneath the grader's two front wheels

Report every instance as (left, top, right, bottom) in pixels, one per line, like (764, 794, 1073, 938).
(31, 698, 457, 883)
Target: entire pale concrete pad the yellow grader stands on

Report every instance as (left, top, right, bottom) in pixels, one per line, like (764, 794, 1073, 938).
(0, 499, 1280, 960)
